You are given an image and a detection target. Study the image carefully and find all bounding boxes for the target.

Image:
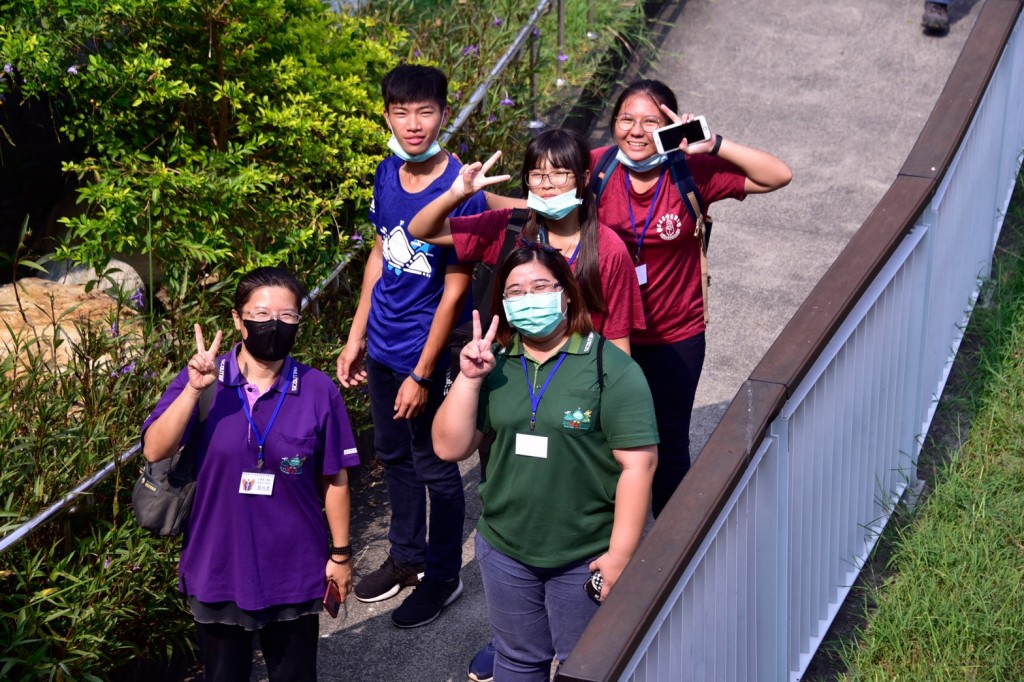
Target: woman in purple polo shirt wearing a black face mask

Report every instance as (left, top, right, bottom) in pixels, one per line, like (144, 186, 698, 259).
(142, 267, 358, 681)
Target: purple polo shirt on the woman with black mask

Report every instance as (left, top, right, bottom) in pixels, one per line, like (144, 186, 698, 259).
(142, 344, 359, 610)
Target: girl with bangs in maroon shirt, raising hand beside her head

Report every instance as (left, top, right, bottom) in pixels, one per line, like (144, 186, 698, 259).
(409, 129, 644, 353)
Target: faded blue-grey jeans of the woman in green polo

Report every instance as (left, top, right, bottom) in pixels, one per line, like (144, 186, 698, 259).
(476, 528, 597, 682)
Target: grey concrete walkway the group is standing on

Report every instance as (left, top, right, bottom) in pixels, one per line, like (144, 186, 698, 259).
(290, 0, 980, 682)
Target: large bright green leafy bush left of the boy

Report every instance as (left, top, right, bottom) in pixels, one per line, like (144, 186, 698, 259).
(0, 0, 398, 301)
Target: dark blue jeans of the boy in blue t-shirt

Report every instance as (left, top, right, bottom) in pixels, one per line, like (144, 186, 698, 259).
(366, 355, 466, 581)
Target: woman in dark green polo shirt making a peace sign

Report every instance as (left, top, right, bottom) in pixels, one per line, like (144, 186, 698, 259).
(433, 245, 657, 682)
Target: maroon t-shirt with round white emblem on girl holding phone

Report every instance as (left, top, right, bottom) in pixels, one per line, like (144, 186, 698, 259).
(590, 147, 746, 345)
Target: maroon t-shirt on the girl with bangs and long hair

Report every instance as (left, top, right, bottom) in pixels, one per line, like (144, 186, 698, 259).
(450, 204, 644, 339)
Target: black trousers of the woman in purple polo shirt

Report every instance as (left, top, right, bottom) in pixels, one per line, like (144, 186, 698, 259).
(196, 613, 319, 682)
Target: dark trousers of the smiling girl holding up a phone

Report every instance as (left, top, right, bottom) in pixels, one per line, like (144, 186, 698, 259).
(632, 332, 706, 518)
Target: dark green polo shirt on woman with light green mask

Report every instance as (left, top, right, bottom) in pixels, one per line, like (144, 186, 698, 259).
(477, 334, 657, 568)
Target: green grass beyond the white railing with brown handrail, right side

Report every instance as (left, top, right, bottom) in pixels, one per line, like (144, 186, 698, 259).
(844, 176, 1024, 682)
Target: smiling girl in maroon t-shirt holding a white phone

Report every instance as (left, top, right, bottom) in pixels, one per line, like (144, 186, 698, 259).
(591, 80, 793, 516)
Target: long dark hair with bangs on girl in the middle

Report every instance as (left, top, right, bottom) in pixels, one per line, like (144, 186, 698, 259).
(520, 128, 608, 313)
